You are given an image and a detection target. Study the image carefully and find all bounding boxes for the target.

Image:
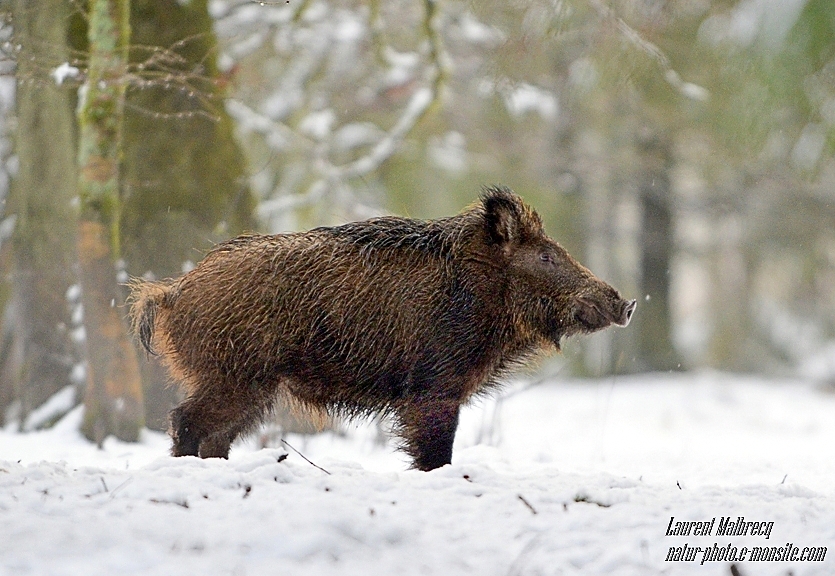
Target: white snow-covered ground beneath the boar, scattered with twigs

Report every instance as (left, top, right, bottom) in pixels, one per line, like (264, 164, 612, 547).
(0, 373, 835, 576)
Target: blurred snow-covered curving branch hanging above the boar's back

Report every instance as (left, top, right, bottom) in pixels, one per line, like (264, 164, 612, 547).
(235, 0, 448, 224)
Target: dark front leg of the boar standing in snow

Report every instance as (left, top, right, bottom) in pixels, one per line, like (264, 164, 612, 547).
(396, 399, 459, 470)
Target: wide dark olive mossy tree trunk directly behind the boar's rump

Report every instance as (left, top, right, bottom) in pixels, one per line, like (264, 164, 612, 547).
(122, 0, 255, 429)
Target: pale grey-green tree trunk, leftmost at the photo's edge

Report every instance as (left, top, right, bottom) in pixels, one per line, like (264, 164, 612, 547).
(2, 0, 78, 425)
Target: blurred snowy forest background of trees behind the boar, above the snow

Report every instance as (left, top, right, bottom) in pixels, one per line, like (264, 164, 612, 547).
(0, 0, 835, 443)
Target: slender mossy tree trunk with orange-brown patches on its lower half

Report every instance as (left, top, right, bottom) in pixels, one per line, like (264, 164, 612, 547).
(78, 0, 143, 445)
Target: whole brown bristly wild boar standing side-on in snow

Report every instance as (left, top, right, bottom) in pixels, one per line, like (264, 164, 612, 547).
(131, 187, 635, 470)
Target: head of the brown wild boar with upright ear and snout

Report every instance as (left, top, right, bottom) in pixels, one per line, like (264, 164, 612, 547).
(482, 188, 635, 348)
